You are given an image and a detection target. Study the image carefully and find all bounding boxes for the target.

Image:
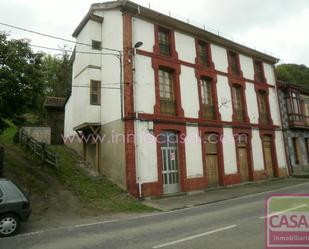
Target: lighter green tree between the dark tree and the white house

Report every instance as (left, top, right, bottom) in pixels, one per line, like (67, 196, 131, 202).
(42, 48, 72, 97)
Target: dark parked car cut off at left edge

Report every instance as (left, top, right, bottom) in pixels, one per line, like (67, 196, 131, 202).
(0, 178, 31, 237)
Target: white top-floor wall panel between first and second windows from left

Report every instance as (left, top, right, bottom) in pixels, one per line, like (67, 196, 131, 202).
(175, 32, 196, 63)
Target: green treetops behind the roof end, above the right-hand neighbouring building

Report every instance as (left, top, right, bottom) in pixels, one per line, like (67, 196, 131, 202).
(276, 64, 309, 89)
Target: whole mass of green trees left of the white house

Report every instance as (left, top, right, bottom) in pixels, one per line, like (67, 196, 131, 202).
(0, 32, 72, 134)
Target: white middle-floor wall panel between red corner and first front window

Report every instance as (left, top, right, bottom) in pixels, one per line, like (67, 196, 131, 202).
(135, 55, 156, 114)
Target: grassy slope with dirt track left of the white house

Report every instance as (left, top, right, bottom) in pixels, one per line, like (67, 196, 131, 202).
(0, 126, 153, 214)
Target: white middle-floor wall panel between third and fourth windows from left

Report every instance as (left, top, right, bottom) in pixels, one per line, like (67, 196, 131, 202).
(246, 83, 259, 124)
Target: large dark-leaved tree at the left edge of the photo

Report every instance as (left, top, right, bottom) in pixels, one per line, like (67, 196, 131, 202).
(0, 33, 43, 133)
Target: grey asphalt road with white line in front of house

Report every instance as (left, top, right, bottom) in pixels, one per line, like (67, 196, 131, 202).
(0, 183, 309, 249)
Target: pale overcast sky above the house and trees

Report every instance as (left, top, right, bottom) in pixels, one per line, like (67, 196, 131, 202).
(0, 0, 309, 66)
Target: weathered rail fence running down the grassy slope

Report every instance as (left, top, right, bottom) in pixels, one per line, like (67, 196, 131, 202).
(19, 129, 59, 169)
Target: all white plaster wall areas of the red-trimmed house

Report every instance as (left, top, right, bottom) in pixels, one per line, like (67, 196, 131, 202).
(65, 2, 287, 196)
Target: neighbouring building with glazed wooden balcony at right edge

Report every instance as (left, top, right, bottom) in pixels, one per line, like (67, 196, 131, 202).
(278, 82, 309, 174)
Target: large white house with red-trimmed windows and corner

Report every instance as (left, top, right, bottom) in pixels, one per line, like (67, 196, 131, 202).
(65, 1, 288, 196)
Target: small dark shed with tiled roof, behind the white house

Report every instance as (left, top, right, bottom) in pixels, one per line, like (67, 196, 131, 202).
(44, 96, 66, 144)
